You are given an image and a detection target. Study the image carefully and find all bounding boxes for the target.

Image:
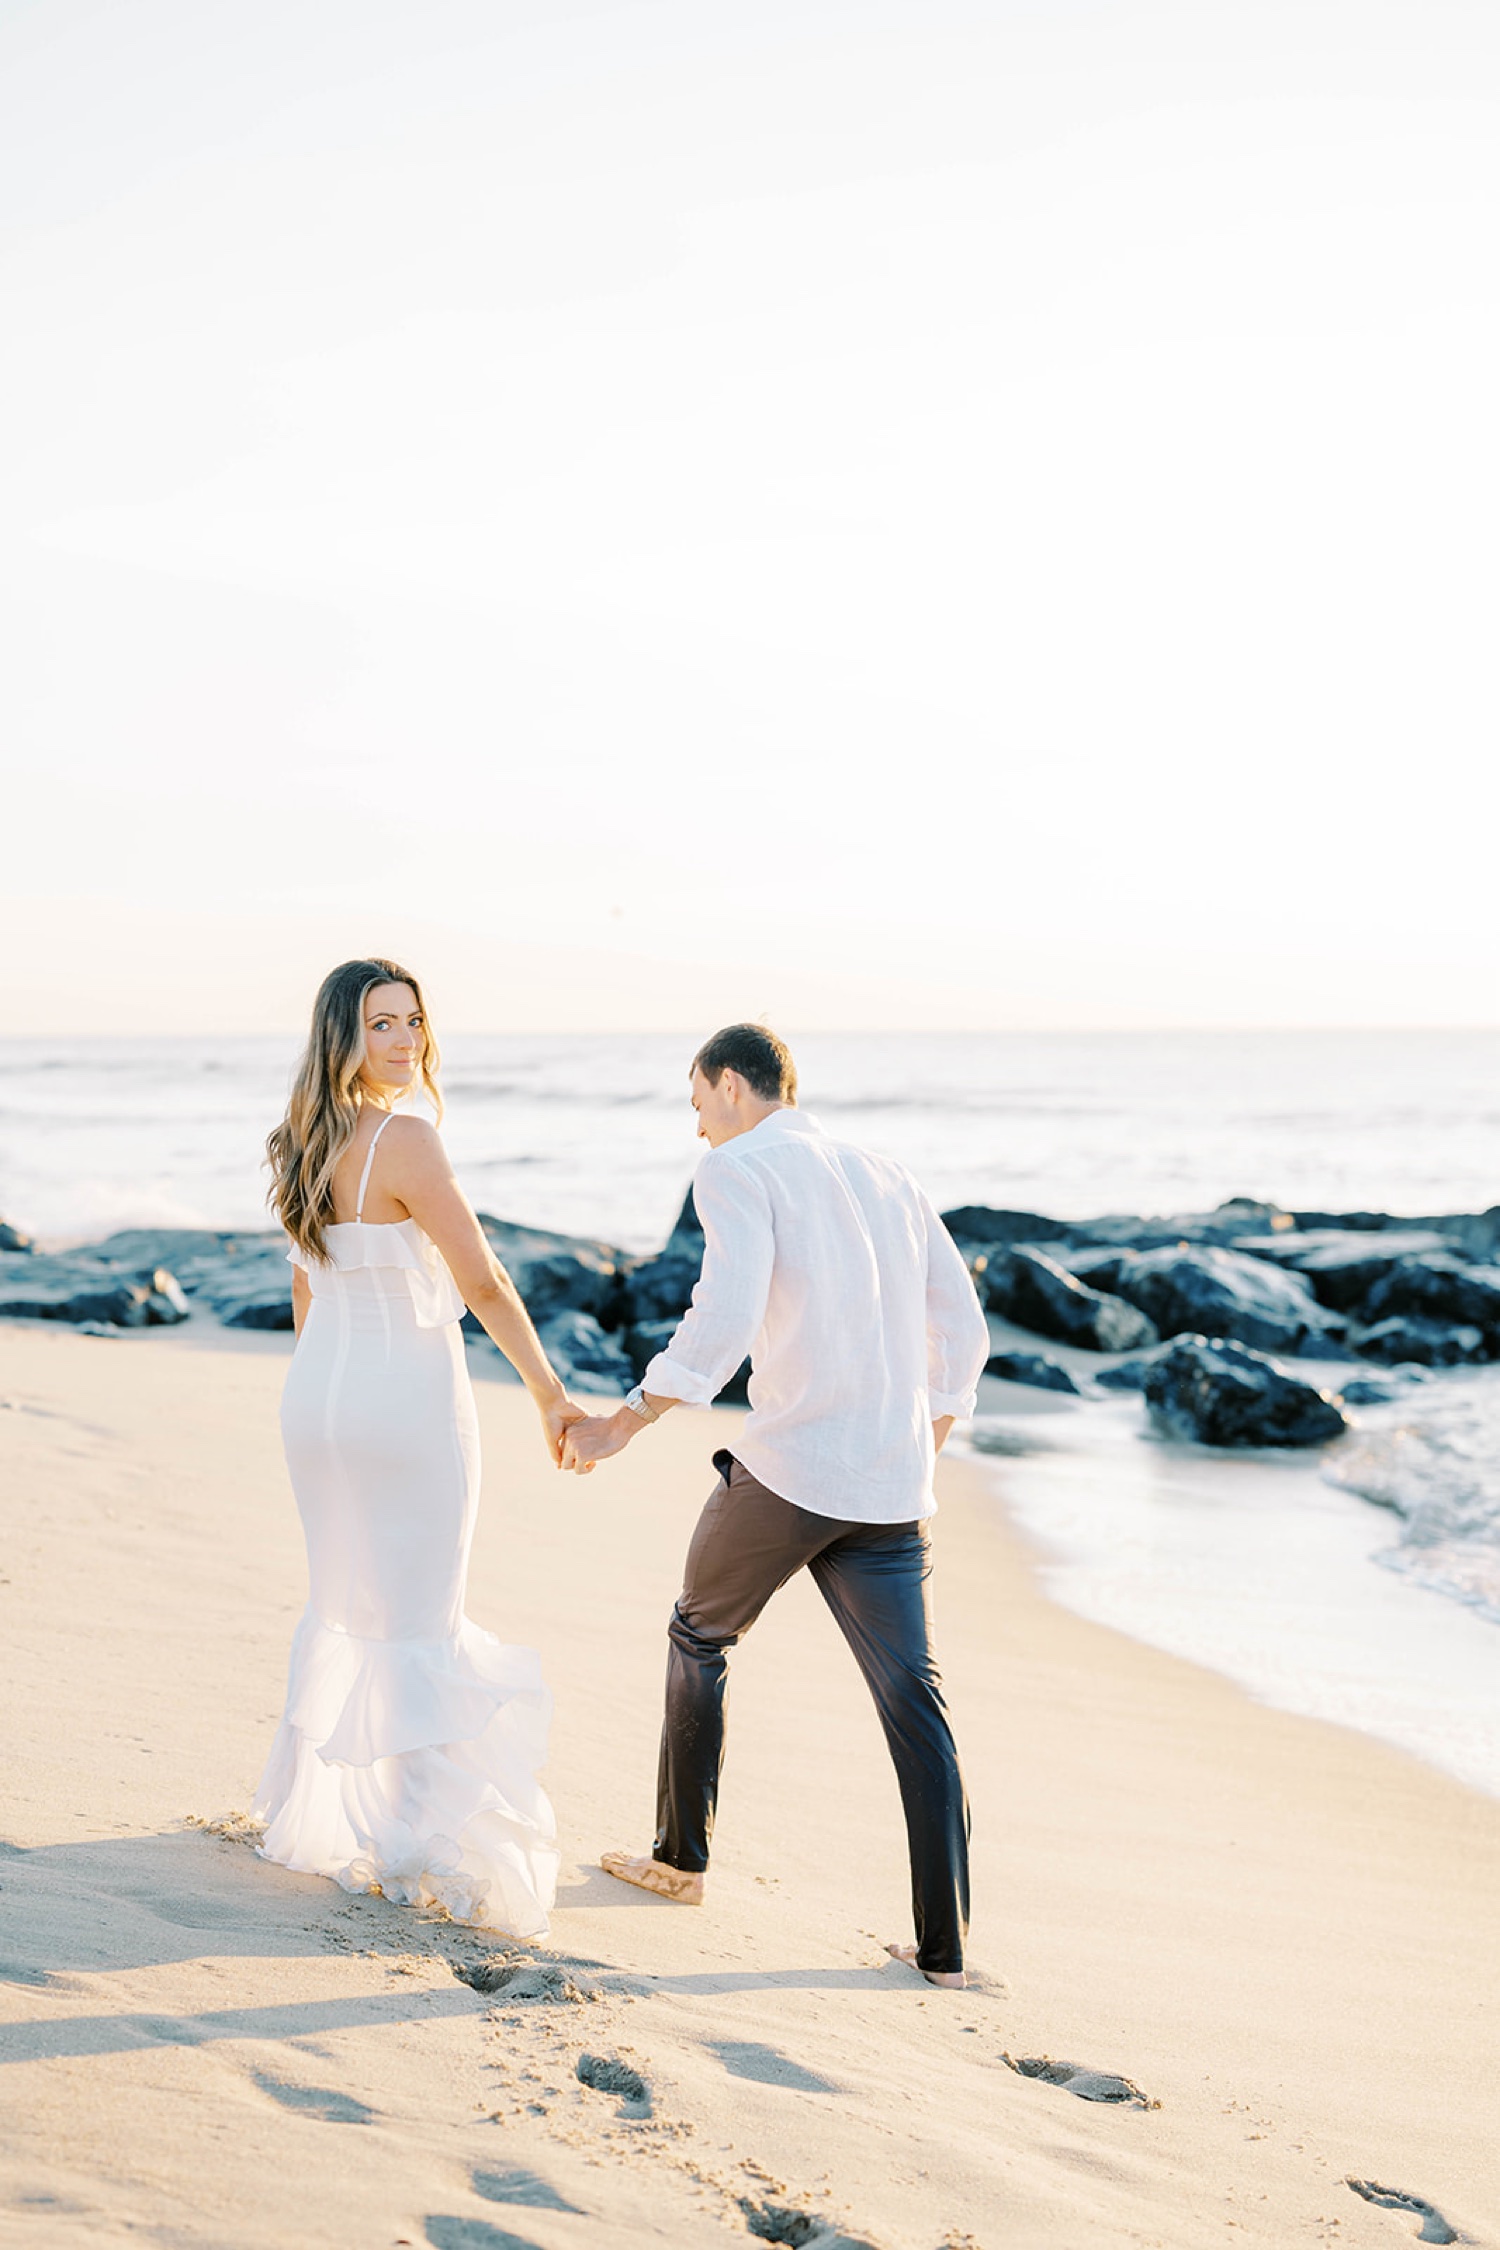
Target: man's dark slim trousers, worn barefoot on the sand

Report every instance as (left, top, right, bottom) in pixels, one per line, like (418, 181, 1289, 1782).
(652, 1454, 969, 1969)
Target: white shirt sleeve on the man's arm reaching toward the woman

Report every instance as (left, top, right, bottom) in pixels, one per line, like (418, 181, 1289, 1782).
(641, 1150, 776, 1406)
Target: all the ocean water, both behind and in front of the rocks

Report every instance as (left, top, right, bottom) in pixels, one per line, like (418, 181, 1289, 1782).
(0, 1033, 1500, 1791)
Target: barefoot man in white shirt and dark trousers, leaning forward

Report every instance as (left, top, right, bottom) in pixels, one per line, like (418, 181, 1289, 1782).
(562, 1024, 990, 1985)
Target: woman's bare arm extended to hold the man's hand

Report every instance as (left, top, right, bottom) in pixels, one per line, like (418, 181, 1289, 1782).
(380, 1118, 585, 1463)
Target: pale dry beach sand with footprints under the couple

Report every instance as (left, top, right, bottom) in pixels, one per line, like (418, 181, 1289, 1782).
(0, 1328, 1500, 2250)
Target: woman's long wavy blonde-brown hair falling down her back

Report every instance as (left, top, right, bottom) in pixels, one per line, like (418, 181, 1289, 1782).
(265, 959, 443, 1260)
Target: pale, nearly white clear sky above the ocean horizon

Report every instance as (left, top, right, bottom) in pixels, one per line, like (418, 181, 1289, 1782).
(0, 0, 1500, 1033)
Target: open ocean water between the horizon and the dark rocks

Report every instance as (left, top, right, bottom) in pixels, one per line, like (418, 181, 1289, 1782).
(0, 1031, 1500, 1249)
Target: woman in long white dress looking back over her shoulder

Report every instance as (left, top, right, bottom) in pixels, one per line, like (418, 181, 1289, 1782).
(256, 961, 582, 1937)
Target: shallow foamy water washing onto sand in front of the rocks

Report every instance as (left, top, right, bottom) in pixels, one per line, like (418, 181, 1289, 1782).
(965, 1384, 1500, 1798)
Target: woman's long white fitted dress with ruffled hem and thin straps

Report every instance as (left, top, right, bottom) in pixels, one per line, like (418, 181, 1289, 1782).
(254, 1118, 558, 1937)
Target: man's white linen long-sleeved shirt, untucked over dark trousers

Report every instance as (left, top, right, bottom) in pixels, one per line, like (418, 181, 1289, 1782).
(641, 1109, 990, 1523)
